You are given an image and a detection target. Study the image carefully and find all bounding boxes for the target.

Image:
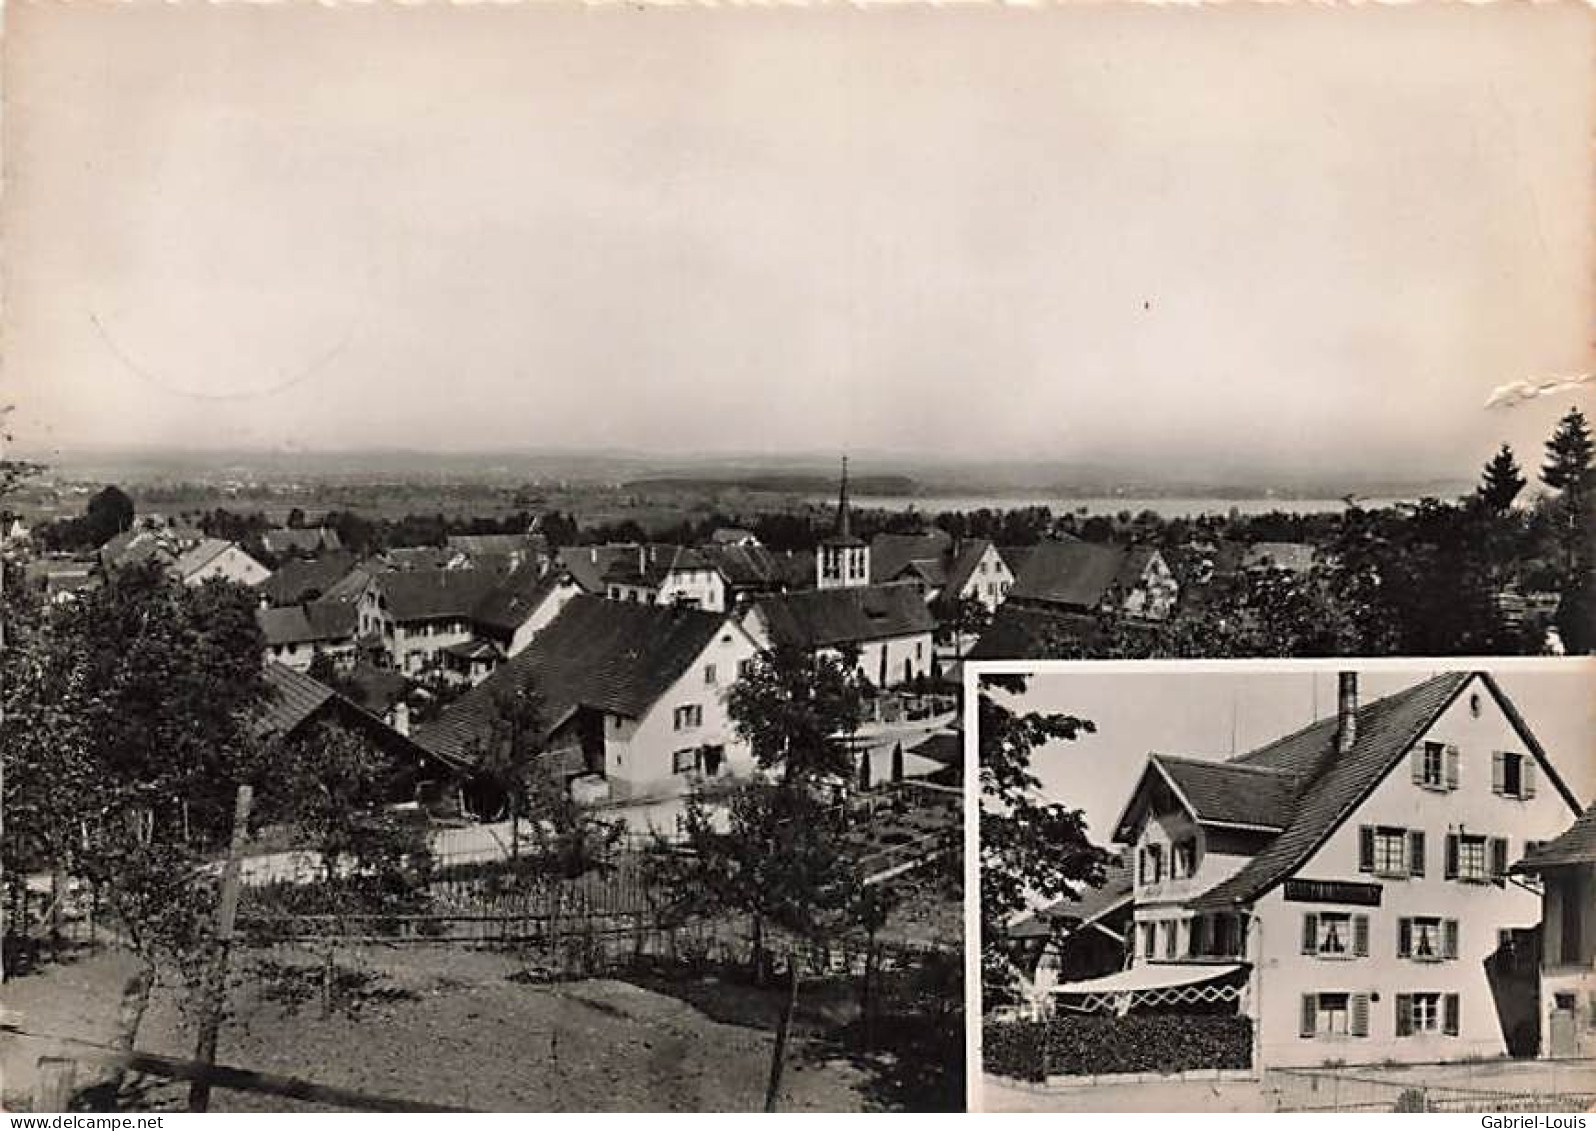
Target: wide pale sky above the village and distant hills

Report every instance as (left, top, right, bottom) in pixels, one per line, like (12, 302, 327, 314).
(0, 0, 1596, 475)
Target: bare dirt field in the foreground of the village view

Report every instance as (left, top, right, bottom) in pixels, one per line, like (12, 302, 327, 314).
(0, 948, 912, 1112)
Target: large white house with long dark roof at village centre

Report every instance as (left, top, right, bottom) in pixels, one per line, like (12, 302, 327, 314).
(417, 593, 758, 801)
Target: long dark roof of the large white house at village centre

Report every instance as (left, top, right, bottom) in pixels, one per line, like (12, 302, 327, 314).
(415, 593, 741, 759)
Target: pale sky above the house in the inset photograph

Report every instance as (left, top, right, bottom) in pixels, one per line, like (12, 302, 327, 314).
(1010, 660, 1596, 847)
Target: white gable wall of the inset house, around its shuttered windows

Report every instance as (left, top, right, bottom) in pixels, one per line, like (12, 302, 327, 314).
(1251, 680, 1575, 1066)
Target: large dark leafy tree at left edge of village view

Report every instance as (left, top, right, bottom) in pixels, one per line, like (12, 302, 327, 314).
(0, 562, 270, 1045)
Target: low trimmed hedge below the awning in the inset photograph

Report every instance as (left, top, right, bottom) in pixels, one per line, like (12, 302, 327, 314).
(982, 1013, 1253, 1082)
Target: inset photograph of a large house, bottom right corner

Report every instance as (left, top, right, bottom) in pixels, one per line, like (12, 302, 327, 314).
(970, 660, 1596, 1112)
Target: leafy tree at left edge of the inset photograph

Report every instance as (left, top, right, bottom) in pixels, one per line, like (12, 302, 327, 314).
(977, 676, 1109, 1008)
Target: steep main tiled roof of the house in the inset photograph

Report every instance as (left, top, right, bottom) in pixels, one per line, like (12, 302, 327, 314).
(1192, 672, 1578, 909)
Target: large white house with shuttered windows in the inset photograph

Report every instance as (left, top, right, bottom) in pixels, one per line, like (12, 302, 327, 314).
(1055, 672, 1578, 1066)
